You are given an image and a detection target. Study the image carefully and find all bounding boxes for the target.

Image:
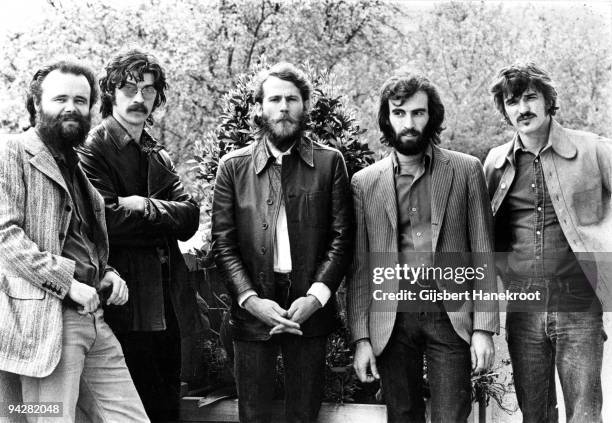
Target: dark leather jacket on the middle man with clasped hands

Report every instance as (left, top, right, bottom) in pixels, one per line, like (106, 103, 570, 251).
(212, 136, 353, 340)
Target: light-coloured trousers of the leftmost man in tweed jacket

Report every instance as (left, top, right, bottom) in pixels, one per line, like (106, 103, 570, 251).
(20, 308, 149, 423)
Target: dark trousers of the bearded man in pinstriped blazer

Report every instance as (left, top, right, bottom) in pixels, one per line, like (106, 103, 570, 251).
(377, 311, 472, 423)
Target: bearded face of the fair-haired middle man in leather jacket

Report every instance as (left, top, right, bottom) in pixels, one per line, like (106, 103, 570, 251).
(260, 76, 306, 147)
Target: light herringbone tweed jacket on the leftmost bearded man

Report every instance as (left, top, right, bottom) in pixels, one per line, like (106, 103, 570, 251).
(0, 129, 108, 377)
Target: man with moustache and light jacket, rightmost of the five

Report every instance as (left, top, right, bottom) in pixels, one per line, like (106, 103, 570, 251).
(485, 63, 612, 422)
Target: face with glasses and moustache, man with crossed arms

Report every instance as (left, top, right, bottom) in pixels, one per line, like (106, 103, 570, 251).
(113, 73, 157, 126)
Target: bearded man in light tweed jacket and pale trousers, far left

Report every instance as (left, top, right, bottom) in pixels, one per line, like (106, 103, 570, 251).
(0, 61, 148, 422)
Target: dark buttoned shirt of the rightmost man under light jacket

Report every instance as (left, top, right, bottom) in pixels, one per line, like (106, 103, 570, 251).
(500, 137, 582, 278)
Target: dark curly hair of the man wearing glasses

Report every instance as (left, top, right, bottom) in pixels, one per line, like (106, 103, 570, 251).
(100, 49, 168, 125)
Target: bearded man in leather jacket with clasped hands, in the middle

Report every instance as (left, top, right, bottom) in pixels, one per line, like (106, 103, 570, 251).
(212, 63, 352, 422)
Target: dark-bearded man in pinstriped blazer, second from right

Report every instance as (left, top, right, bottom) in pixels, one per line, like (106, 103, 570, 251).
(348, 75, 499, 422)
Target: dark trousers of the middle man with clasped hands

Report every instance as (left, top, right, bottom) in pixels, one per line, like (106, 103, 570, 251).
(234, 334, 326, 423)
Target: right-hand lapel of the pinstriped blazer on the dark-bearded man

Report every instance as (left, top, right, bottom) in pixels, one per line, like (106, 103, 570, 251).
(431, 146, 453, 251)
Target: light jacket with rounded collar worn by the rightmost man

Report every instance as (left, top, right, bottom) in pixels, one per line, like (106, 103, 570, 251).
(484, 119, 612, 311)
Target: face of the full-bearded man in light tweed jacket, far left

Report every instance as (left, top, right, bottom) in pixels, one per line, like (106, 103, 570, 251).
(36, 70, 91, 149)
